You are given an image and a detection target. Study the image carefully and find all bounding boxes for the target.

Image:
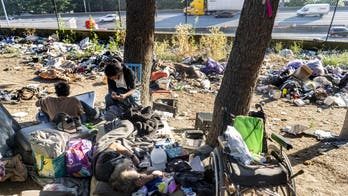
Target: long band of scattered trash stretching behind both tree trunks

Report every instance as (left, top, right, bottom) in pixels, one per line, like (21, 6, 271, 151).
(0, 36, 348, 107)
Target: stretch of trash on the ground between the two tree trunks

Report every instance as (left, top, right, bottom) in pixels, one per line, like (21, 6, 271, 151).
(150, 57, 226, 94)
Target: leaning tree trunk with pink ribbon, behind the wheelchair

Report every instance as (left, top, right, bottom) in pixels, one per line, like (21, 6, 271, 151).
(207, 0, 279, 146)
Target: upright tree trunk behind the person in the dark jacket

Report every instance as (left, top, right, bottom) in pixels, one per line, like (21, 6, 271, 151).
(124, 0, 156, 105)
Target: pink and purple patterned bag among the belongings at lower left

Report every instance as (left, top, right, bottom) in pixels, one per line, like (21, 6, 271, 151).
(66, 139, 92, 177)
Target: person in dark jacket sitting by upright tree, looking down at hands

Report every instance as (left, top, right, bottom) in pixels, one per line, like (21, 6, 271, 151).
(104, 59, 140, 109)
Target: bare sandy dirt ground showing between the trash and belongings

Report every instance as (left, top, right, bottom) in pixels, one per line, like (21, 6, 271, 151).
(0, 57, 348, 196)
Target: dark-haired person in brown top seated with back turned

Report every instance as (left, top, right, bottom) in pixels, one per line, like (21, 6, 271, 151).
(35, 82, 99, 122)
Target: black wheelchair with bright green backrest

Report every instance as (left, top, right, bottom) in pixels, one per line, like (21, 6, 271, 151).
(210, 105, 303, 196)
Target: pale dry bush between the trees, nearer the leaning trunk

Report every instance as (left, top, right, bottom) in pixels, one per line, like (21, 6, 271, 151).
(199, 27, 229, 61)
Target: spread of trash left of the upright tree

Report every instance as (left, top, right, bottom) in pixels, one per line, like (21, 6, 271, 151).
(0, 36, 120, 82)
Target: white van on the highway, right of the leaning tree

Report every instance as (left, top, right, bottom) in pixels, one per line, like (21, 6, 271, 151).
(296, 3, 330, 17)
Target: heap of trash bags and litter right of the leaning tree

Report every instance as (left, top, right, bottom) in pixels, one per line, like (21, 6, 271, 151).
(256, 52, 348, 107)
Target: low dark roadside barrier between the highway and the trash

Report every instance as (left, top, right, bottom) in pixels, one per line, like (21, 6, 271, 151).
(0, 28, 348, 50)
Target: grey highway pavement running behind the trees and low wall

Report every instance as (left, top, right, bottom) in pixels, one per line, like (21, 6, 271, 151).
(0, 9, 348, 40)
